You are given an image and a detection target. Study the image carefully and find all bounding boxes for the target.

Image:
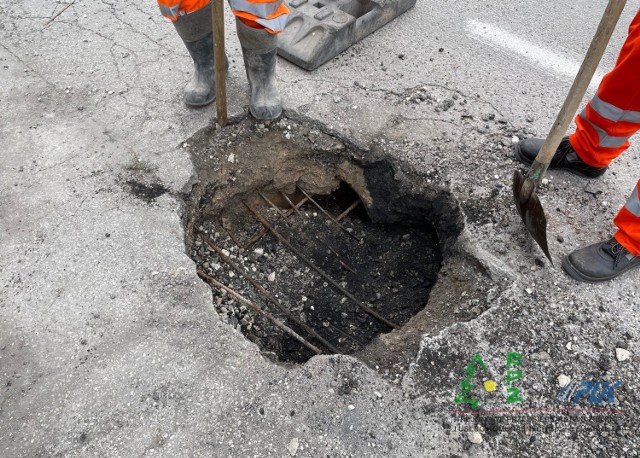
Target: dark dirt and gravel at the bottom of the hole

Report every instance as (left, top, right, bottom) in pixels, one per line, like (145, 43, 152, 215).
(194, 182, 442, 363)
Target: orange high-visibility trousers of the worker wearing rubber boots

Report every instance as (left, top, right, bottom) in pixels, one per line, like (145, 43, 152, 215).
(158, 0, 289, 33)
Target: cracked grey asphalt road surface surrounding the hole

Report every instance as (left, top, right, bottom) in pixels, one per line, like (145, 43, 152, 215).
(0, 0, 640, 457)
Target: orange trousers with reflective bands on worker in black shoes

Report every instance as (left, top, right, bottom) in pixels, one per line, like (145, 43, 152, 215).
(569, 10, 640, 256)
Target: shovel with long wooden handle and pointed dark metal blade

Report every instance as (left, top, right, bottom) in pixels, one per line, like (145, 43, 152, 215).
(513, 0, 626, 264)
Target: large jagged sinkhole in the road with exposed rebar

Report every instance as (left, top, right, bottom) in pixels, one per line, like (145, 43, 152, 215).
(185, 115, 464, 363)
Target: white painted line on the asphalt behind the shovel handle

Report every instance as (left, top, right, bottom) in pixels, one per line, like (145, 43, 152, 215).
(467, 19, 605, 90)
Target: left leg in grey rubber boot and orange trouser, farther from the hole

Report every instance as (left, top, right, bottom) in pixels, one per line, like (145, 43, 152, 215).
(158, 0, 216, 106)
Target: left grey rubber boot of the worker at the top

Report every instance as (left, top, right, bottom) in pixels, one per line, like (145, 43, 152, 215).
(173, 3, 216, 107)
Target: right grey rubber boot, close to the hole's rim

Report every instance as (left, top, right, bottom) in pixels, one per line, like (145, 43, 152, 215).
(236, 19, 282, 120)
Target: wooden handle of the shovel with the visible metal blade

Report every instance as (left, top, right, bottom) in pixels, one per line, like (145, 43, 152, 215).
(528, 0, 627, 184)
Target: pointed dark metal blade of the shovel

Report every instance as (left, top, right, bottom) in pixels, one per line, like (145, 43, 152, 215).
(513, 170, 553, 264)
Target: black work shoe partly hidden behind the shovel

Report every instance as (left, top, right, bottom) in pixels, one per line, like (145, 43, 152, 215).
(514, 137, 607, 178)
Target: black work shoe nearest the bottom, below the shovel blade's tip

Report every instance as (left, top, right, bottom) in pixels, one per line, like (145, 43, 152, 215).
(562, 238, 640, 283)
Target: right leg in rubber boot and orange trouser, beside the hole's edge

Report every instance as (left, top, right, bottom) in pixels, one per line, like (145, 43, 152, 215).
(229, 0, 289, 120)
